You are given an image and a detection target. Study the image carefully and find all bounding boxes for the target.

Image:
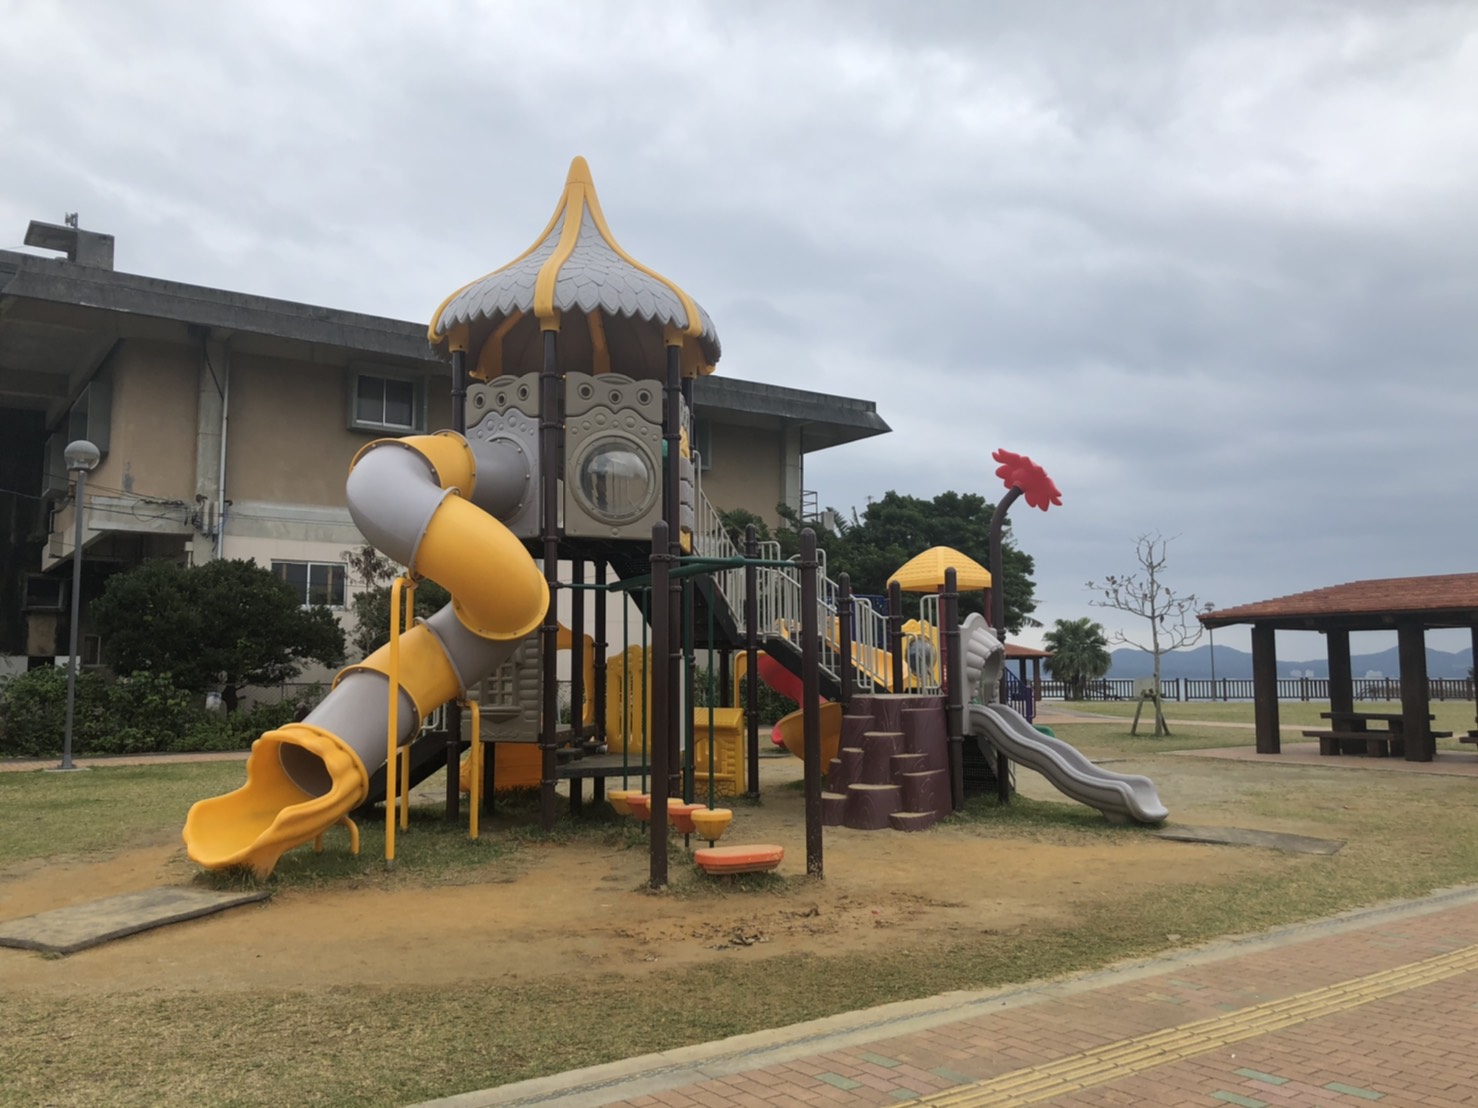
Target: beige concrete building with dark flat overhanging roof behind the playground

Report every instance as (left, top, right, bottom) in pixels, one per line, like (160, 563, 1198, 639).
(0, 214, 888, 672)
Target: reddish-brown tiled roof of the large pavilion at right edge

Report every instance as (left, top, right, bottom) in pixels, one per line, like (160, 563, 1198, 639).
(1200, 573, 1478, 628)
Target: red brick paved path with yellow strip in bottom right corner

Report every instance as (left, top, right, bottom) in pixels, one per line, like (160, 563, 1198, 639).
(419, 888, 1478, 1108)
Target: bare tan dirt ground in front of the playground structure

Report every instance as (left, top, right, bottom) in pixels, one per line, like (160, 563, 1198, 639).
(0, 756, 1288, 996)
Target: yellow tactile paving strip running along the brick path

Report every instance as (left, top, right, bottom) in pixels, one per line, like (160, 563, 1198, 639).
(905, 945, 1478, 1108)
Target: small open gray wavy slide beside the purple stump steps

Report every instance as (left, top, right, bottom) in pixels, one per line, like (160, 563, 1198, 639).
(967, 705, 1171, 823)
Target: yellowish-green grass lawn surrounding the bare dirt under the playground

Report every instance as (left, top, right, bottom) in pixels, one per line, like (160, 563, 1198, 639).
(0, 741, 1478, 1105)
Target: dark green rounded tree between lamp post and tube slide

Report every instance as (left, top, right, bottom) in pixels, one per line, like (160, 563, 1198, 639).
(93, 560, 344, 711)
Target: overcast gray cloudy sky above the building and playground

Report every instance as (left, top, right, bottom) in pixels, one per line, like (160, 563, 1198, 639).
(0, 0, 1478, 657)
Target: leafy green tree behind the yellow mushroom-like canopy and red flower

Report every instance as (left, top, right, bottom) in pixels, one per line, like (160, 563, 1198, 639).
(817, 492, 1039, 634)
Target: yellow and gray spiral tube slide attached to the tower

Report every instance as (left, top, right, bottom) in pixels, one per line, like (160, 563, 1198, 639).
(185, 431, 548, 878)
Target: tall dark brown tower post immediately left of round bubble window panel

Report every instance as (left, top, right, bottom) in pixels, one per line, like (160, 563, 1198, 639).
(539, 331, 560, 830)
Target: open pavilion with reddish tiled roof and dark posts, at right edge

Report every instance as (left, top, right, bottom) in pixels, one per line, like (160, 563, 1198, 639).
(1200, 573, 1478, 762)
